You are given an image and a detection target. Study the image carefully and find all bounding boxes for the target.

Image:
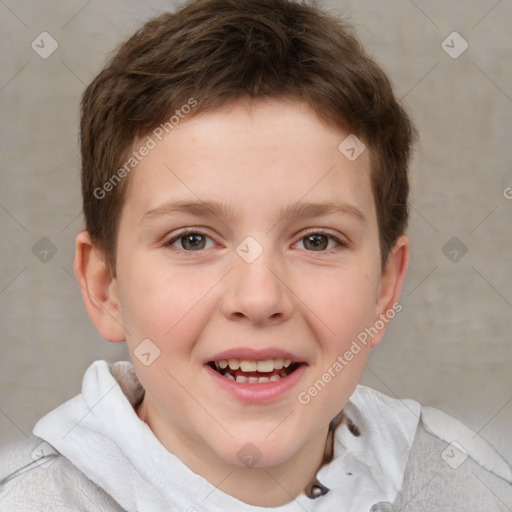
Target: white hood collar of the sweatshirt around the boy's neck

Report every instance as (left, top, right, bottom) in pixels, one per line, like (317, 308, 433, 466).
(33, 361, 421, 512)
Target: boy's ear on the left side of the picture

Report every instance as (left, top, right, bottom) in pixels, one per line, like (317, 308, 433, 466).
(74, 231, 126, 342)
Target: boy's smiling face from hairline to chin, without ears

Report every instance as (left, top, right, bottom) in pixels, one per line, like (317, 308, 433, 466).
(111, 100, 400, 466)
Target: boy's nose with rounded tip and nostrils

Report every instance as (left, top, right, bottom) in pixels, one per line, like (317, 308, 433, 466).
(222, 246, 293, 325)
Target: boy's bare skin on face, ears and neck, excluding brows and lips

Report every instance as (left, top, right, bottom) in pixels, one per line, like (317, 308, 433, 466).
(75, 99, 409, 507)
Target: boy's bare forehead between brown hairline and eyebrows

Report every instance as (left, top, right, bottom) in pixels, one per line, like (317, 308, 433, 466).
(125, 100, 375, 228)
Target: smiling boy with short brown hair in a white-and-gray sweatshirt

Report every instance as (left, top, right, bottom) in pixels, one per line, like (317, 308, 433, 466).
(0, 0, 512, 512)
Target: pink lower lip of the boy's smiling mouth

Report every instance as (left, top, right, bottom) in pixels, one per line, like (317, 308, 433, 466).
(204, 363, 306, 403)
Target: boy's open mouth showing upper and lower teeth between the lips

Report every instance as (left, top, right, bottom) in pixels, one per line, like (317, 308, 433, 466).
(208, 358, 304, 384)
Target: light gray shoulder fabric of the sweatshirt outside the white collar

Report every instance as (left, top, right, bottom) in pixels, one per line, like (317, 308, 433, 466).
(0, 422, 512, 512)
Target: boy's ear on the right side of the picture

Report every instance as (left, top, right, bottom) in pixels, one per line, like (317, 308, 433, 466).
(370, 235, 410, 347)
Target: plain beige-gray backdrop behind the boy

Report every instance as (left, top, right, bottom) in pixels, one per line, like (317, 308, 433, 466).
(0, 0, 512, 461)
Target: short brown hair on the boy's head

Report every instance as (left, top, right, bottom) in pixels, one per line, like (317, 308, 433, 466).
(80, 0, 416, 275)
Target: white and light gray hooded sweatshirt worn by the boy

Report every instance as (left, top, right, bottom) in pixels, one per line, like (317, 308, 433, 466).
(0, 361, 512, 512)
